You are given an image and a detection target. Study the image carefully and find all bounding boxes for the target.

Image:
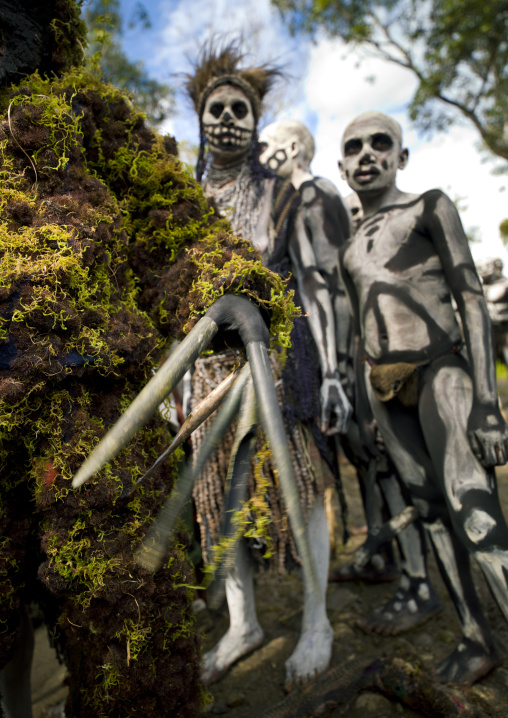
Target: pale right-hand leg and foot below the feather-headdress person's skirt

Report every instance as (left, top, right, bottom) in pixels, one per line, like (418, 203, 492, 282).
(285, 497, 333, 690)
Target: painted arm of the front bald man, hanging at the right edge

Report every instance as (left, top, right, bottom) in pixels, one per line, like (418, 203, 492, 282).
(426, 194, 508, 466)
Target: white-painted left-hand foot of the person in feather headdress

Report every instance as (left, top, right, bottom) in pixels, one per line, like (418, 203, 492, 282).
(201, 624, 264, 686)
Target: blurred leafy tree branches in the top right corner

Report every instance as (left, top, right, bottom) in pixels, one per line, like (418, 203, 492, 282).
(272, 0, 508, 160)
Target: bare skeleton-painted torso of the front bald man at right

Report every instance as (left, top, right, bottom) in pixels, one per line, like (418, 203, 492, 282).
(343, 190, 461, 362)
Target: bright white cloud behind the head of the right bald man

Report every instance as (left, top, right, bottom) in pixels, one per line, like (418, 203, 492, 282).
(305, 35, 508, 268)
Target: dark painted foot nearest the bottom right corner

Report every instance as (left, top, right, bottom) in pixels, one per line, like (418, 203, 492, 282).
(434, 638, 501, 685)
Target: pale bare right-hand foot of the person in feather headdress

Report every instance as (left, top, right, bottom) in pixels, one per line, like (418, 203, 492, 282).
(284, 619, 333, 692)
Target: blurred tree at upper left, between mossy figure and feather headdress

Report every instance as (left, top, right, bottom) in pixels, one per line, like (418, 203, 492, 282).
(83, 0, 174, 125)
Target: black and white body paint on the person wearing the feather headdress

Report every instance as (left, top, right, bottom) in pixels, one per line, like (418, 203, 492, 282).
(201, 91, 342, 687)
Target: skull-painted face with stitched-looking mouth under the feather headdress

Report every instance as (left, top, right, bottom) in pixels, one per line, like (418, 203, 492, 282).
(201, 85, 256, 163)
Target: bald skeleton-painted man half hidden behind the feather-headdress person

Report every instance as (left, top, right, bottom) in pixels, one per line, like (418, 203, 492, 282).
(259, 121, 434, 612)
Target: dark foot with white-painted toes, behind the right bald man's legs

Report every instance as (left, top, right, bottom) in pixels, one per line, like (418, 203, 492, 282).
(356, 579, 441, 636)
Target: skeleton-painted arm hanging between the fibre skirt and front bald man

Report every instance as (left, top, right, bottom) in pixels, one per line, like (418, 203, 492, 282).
(289, 212, 353, 434)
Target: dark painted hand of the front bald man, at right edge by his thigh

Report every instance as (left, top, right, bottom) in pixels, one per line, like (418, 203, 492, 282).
(467, 404, 508, 467)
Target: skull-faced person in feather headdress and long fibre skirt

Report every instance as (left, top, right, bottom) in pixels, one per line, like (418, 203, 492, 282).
(188, 46, 351, 685)
